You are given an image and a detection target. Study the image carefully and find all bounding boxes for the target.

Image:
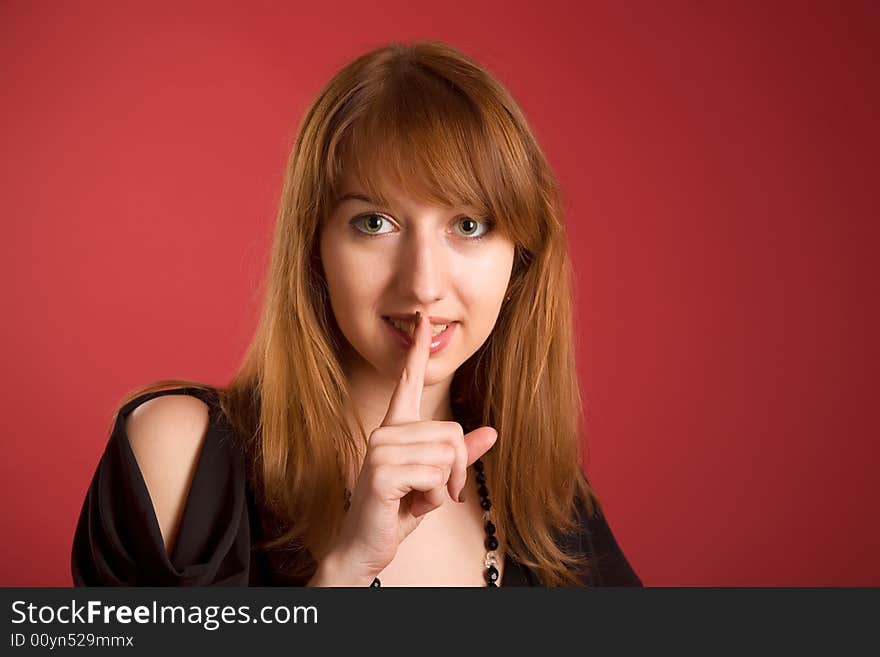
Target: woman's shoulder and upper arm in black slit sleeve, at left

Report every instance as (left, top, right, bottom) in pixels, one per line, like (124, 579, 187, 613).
(71, 384, 251, 586)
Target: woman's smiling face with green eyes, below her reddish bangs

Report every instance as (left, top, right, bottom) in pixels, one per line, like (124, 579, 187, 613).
(319, 178, 514, 385)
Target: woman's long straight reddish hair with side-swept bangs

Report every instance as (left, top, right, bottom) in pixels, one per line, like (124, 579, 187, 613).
(120, 41, 599, 586)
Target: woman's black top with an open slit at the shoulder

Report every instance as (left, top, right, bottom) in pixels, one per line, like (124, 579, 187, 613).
(71, 388, 642, 586)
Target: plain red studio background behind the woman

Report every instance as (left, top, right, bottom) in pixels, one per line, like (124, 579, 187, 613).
(0, 0, 880, 586)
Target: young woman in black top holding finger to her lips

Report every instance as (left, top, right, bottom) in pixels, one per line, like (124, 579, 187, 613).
(72, 42, 641, 586)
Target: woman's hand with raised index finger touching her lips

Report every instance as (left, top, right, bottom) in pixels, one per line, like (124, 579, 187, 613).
(310, 310, 498, 586)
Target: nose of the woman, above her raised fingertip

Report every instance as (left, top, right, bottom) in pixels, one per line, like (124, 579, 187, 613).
(396, 224, 449, 308)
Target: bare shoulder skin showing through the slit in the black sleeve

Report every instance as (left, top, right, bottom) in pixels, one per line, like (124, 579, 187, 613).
(125, 394, 210, 554)
